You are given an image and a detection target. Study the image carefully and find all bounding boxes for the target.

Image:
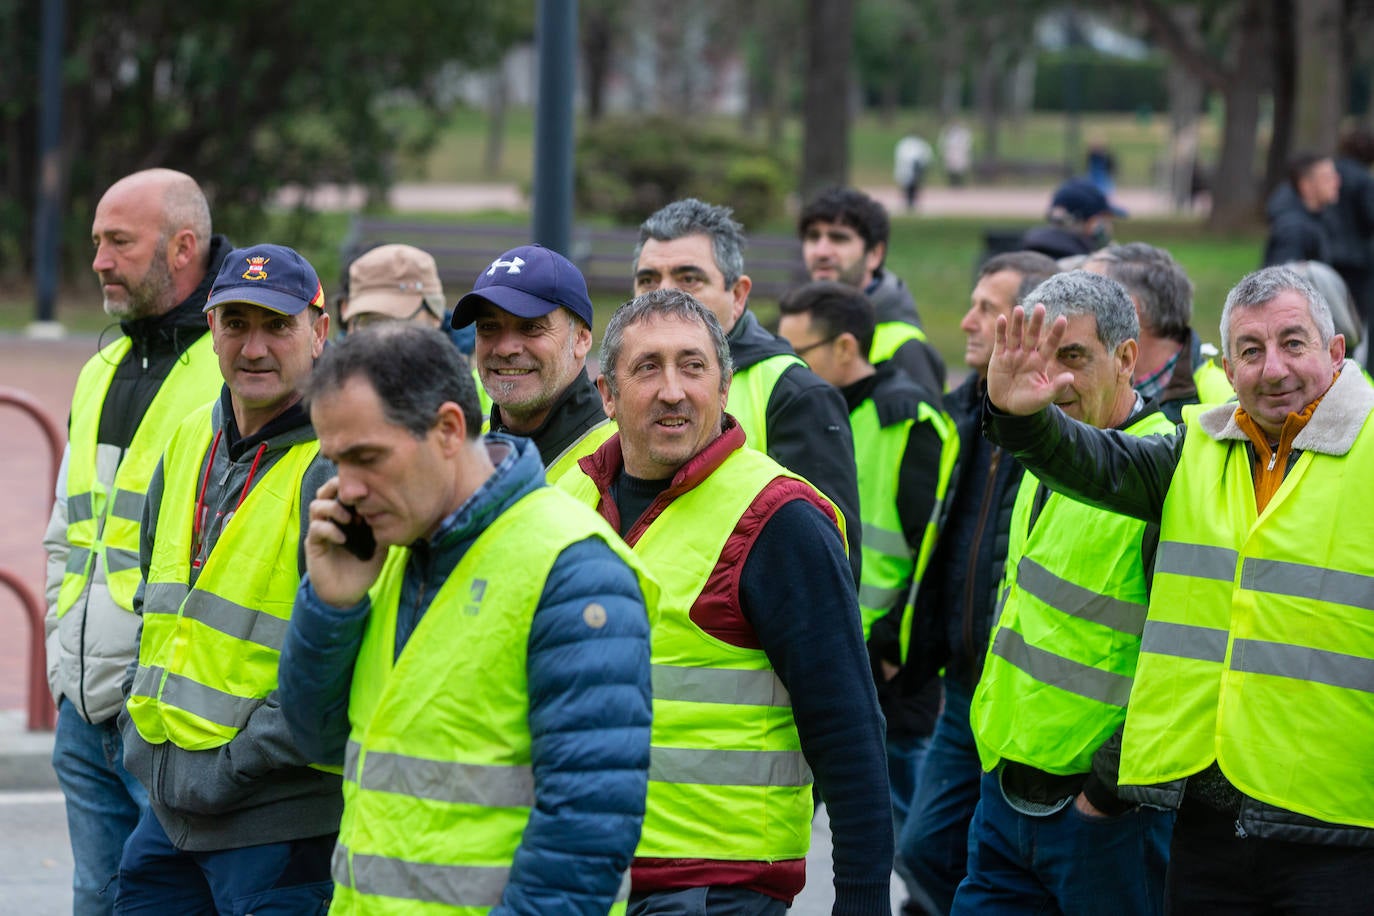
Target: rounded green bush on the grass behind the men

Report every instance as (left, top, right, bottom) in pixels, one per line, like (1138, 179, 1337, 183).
(576, 118, 794, 227)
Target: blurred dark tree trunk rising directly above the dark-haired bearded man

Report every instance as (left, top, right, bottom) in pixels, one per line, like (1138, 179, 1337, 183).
(800, 0, 855, 201)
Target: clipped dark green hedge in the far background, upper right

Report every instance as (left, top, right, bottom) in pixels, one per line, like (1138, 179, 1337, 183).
(1035, 49, 1169, 111)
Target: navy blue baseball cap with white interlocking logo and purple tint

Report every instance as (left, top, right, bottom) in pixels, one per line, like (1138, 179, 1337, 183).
(452, 244, 592, 328)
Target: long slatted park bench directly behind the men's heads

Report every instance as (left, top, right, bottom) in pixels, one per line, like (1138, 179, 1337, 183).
(342, 214, 808, 301)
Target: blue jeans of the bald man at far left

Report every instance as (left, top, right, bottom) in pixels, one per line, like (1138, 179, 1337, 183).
(52, 696, 148, 916)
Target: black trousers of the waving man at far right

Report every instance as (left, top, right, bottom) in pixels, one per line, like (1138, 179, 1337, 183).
(1164, 801, 1374, 916)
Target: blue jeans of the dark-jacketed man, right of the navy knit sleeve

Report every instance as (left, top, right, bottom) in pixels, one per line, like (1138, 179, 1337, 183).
(897, 678, 982, 913)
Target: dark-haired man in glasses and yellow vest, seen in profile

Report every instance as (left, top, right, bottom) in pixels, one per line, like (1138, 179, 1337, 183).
(778, 280, 959, 911)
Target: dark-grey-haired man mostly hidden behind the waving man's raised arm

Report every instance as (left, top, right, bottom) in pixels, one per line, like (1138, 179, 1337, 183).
(1083, 242, 1235, 423)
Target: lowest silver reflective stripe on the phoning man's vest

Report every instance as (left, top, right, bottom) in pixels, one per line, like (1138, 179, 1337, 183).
(333, 845, 510, 906)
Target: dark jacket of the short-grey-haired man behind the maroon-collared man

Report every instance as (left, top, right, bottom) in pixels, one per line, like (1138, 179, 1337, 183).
(725, 309, 863, 582)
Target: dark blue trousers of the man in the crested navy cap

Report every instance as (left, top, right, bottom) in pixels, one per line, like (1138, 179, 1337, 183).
(114, 812, 338, 916)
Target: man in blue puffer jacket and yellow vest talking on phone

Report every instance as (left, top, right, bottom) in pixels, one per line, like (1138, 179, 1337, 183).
(280, 325, 655, 916)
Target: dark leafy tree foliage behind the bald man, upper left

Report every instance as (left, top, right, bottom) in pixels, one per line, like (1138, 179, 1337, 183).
(0, 0, 529, 273)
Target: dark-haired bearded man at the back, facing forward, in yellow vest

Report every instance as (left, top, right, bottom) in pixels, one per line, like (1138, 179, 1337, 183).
(797, 188, 945, 407)
